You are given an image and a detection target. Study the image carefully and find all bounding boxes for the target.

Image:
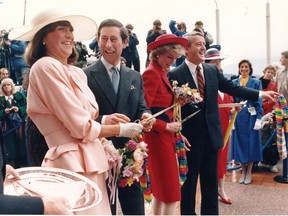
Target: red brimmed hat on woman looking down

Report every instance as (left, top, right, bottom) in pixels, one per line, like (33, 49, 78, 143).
(147, 34, 188, 51)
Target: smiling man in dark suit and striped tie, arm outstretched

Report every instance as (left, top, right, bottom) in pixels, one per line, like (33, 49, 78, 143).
(168, 31, 278, 215)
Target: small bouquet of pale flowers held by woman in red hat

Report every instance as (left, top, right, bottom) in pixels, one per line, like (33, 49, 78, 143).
(172, 80, 203, 105)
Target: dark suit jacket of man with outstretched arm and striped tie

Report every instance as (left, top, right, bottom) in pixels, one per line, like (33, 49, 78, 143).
(168, 62, 259, 149)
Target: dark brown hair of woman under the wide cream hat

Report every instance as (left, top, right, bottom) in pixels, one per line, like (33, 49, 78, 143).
(25, 20, 78, 66)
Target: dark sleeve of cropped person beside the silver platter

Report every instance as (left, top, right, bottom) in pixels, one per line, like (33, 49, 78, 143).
(0, 127, 44, 214)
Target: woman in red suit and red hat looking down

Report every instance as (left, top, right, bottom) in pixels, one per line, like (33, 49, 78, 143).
(142, 34, 188, 215)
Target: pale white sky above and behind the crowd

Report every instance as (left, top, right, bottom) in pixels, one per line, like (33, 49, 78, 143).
(0, 0, 288, 74)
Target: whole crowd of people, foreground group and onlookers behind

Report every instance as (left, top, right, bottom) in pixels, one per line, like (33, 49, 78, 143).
(0, 7, 288, 215)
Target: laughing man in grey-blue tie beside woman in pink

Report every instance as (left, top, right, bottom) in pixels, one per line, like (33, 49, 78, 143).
(84, 19, 155, 215)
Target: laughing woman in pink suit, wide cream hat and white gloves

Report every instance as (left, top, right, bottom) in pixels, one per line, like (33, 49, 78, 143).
(9, 9, 143, 215)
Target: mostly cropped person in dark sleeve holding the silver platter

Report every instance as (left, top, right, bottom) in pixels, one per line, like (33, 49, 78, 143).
(0, 127, 73, 215)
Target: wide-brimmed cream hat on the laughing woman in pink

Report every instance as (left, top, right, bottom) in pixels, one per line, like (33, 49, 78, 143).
(8, 9, 97, 41)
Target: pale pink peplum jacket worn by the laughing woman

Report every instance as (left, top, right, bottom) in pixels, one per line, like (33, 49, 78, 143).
(27, 57, 108, 173)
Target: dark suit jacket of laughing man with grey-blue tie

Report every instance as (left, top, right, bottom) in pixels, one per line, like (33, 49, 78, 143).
(84, 60, 150, 148)
